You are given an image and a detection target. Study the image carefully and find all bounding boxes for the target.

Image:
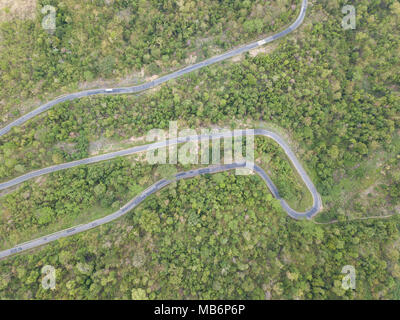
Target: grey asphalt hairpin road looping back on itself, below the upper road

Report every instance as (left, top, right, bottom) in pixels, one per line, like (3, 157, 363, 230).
(0, 129, 322, 259)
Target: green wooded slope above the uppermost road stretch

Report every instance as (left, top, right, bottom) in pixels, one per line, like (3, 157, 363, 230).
(0, 0, 298, 122)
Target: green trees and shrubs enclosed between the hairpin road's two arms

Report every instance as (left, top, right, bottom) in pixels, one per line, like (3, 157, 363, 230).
(0, 137, 312, 249)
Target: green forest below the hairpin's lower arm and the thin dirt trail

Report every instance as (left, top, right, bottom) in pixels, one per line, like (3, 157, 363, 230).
(0, 173, 400, 299)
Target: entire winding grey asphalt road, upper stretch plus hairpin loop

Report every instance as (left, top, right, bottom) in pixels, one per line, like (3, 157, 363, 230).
(0, 0, 322, 259)
